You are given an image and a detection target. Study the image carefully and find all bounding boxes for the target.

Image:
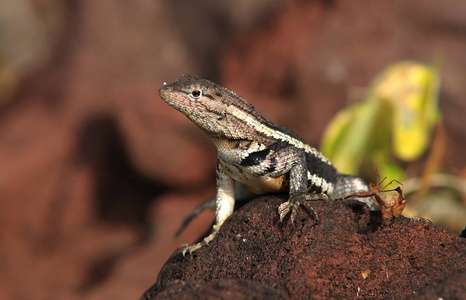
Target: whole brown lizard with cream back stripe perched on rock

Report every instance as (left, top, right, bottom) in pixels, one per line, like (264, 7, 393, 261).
(159, 75, 374, 255)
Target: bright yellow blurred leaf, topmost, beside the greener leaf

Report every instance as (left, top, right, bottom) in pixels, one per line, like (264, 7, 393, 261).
(372, 62, 440, 161)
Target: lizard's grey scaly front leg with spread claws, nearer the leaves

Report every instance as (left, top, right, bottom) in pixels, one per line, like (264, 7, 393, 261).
(278, 151, 328, 223)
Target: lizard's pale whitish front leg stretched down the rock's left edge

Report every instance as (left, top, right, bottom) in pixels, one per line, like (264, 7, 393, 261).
(183, 162, 235, 255)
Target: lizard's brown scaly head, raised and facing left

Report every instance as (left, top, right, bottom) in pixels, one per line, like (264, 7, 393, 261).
(159, 75, 260, 139)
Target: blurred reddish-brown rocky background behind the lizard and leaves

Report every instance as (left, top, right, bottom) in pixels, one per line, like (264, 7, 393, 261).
(0, 0, 466, 299)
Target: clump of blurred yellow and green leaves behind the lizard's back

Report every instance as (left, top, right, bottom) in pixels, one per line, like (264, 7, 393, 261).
(321, 62, 440, 180)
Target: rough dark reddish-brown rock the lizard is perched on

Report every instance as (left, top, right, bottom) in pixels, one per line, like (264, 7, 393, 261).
(142, 196, 466, 299)
